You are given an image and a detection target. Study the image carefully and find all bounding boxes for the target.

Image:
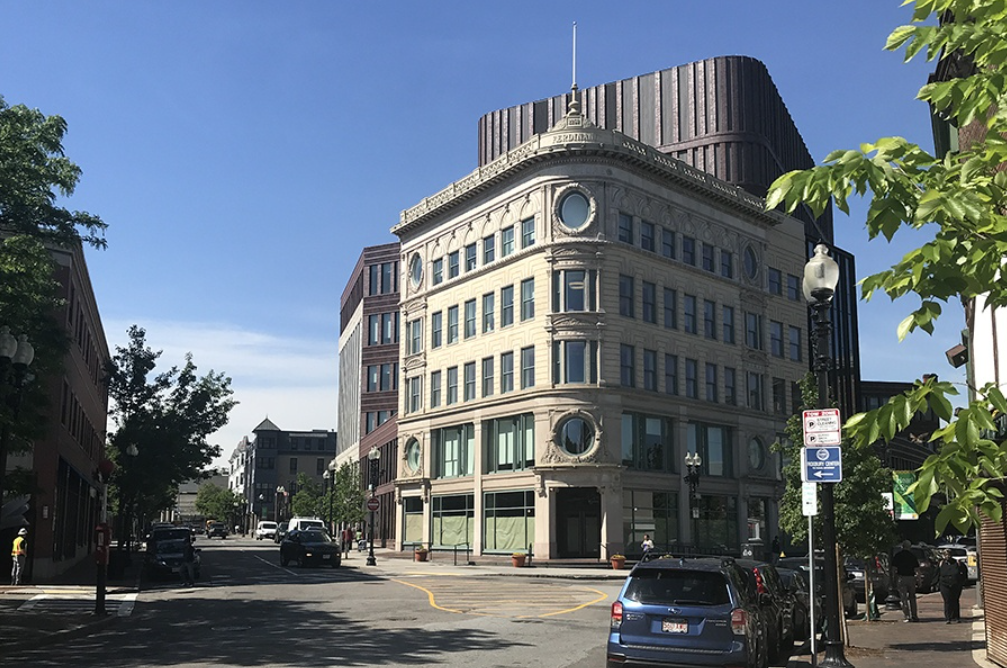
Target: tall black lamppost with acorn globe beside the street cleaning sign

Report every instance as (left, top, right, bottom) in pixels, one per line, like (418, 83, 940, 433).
(804, 244, 852, 668)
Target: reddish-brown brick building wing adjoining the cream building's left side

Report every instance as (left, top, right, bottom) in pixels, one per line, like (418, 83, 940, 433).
(336, 243, 401, 546)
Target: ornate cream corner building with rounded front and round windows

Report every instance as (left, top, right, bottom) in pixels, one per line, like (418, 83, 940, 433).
(393, 98, 808, 558)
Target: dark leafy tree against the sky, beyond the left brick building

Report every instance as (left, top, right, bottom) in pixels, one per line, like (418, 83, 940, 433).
(106, 325, 236, 532)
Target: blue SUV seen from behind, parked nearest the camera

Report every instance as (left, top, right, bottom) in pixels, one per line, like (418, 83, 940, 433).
(606, 556, 769, 668)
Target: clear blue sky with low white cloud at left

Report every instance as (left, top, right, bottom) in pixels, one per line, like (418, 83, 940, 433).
(0, 0, 964, 467)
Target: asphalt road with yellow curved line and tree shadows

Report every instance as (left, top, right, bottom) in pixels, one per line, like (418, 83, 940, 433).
(0, 538, 619, 668)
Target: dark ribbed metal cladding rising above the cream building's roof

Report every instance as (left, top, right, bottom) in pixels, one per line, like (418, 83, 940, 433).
(478, 55, 833, 244)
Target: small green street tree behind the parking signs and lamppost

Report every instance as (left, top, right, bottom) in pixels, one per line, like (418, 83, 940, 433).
(773, 376, 895, 557)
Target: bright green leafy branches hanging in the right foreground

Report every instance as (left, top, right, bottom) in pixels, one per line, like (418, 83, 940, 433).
(766, 0, 1007, 534)
